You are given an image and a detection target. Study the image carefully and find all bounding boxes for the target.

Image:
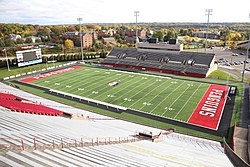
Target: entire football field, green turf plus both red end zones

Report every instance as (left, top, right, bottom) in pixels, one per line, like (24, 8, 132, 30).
(20, 66, 229, 130)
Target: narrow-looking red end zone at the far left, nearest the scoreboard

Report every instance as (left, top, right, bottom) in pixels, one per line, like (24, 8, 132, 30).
(20, 66, 83, 82)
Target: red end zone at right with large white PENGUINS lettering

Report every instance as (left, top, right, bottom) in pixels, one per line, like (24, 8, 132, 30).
(188, 85, 229, 130)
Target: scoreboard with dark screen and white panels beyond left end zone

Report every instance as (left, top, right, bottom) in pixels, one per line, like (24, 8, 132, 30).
(16, 48, 42, 67)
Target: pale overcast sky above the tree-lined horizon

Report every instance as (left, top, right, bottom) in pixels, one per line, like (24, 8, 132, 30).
(0, 0, 250, 25)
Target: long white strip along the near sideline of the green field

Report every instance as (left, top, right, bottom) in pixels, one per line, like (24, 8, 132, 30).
(49, 89, 127, 110)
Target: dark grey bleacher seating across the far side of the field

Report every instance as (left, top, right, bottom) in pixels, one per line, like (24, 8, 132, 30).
(101, 48, 214, 75)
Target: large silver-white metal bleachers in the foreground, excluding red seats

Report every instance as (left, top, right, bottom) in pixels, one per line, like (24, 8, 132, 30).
(0, 83, 233, 167)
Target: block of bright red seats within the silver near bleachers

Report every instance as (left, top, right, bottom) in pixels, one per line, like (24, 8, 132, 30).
(0, 92, 63, 116)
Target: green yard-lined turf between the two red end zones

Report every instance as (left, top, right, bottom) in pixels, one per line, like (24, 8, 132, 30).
(28, 67, 209, 122)
